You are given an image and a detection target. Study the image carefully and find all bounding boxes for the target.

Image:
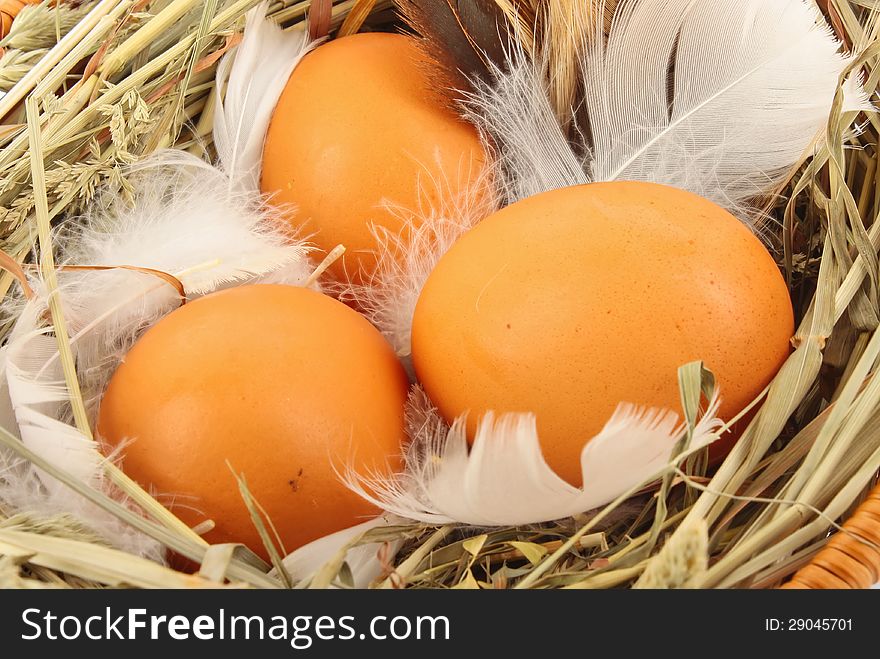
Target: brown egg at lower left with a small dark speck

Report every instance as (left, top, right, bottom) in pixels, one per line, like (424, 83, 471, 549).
(98, 285, 408, 557)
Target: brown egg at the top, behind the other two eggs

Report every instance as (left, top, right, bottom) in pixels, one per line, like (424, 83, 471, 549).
(262, 33, 485, 280)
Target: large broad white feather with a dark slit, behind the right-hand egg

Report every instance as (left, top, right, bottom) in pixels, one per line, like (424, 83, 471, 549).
(584, 0, 869, 209)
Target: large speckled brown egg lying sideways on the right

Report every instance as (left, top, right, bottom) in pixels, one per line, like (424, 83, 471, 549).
(412, 182, 794, 484)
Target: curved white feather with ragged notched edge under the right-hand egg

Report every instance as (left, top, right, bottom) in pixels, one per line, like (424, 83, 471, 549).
(346, 388, 721, 526)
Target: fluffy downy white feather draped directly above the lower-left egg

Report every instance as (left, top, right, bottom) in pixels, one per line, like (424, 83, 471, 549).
(19, 151, 311, 422)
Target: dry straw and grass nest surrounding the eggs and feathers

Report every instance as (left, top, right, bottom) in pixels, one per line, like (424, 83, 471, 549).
(0, 0, 880, 588)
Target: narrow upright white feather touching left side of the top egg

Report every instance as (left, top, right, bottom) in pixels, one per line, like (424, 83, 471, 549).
(214, 2, 319, 190)
